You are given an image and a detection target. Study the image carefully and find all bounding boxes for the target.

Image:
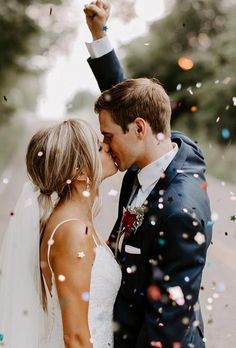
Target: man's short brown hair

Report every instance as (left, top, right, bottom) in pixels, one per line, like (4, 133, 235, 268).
(95, 78, 171, 136)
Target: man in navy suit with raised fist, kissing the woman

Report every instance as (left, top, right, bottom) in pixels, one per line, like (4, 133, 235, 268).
(85, 1, 212, 348)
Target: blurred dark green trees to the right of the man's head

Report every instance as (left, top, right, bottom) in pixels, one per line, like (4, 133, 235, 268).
(124, 0, 236, 142)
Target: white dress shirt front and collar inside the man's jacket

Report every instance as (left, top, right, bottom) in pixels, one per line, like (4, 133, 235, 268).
(130, 143, 178, 208)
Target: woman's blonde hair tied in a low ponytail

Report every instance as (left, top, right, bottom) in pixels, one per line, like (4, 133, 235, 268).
(26, 119, 102, 233)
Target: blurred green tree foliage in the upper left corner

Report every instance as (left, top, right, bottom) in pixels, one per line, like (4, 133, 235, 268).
(0, 0, 72, 124)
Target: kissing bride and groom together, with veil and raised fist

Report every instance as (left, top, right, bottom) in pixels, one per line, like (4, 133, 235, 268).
(0, 0, 212, 348)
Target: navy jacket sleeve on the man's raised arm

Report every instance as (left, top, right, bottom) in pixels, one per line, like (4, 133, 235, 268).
(88, 50, 125, 92)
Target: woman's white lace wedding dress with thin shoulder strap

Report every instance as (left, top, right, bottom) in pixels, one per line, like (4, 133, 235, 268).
(42, 219, 121, 348)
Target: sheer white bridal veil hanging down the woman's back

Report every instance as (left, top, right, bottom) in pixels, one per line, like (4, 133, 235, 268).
(0, 181, 45, 348)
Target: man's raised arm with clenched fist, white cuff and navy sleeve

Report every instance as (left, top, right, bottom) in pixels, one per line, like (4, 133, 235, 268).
(84, 0, 125, 91)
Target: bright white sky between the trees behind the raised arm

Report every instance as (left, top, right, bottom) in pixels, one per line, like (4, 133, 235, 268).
(36, 0, 165, 119)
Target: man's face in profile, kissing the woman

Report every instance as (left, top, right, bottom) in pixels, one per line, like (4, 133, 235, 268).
(99, 110, 137, 171)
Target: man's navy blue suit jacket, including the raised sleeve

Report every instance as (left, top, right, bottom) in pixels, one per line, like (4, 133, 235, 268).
(88, 51, 212, 348)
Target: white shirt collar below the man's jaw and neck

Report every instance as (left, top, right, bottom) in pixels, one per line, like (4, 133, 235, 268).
(137, 143, 178, 192)
